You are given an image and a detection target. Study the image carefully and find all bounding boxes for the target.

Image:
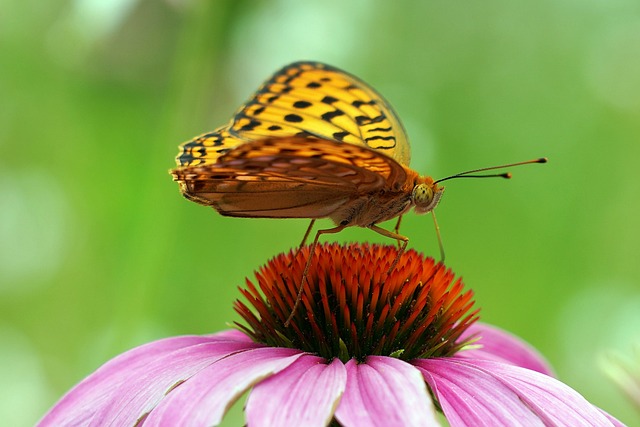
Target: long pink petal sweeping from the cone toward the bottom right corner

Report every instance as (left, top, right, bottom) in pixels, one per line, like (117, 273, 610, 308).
(412, 358, 613, 427)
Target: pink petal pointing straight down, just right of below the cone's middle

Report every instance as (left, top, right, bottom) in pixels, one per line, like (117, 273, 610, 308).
(335, 356, 440, 427)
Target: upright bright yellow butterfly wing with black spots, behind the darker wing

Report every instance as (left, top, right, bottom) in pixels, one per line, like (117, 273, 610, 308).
(177, 62, 410, 166)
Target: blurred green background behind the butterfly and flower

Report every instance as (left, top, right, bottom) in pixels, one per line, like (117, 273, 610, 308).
(0, 0, 640, 426)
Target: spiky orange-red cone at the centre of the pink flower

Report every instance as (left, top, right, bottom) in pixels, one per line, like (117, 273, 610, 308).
(235, 243, 478, 362)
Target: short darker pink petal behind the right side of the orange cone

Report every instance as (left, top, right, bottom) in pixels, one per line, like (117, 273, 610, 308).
(455, 323, 554, 376)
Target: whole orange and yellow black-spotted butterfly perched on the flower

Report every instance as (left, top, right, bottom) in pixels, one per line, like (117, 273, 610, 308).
(171, 62, 546, 323)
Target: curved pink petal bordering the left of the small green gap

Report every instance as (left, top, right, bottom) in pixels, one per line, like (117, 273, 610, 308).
(144, 347, 304, 427)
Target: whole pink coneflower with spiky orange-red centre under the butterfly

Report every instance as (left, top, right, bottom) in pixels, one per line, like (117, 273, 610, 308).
(39, 244, 622, 427)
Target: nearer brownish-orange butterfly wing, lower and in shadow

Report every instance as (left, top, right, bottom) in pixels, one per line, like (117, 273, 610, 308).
(173, 137, 411, 218)
